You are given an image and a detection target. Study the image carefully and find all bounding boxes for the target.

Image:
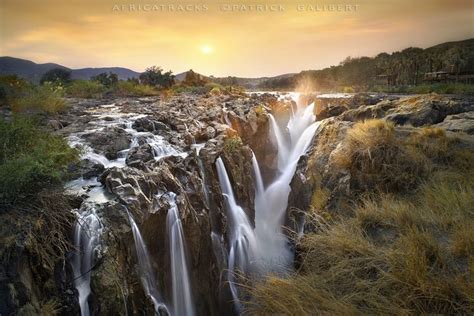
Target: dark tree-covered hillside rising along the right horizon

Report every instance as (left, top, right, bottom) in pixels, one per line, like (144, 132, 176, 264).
(259, 39, 474, 90)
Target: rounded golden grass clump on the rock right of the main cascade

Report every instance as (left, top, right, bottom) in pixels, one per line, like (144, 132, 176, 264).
(333, 120, 427, 192)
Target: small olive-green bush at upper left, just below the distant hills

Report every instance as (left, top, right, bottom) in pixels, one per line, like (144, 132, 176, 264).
(11, 83, 67, 113)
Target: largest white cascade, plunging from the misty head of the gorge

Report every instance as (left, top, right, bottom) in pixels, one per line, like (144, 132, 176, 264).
(252, 95, 319, 273)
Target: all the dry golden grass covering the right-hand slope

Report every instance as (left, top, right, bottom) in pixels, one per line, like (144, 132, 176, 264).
(246, 121, 474, 315)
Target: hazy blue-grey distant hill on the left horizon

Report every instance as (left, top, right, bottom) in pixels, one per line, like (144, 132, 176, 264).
(0, 56, 140, 82)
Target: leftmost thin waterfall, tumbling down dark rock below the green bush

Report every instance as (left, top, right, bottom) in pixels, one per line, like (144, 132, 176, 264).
(72, 204, 103, 316)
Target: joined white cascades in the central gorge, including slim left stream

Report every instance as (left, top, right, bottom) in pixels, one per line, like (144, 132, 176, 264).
(216, 94, 319, 311)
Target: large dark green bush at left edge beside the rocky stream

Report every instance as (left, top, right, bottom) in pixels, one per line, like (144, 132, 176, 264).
(0, 117, 78, 201)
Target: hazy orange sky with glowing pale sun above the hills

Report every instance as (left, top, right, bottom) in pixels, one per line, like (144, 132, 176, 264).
(0, 0, 474, 77)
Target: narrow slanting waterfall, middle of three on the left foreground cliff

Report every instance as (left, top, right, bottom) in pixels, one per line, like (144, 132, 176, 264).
(127, 210, 169, 315)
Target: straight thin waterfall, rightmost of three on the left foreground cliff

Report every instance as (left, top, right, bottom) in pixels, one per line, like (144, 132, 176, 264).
(164, 192, 195, 316)
